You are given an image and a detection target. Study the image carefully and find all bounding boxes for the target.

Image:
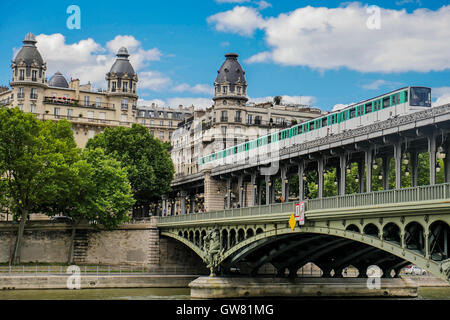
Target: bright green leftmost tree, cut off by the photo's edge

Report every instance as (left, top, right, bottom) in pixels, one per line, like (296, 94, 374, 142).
(0, 108, 78, 263)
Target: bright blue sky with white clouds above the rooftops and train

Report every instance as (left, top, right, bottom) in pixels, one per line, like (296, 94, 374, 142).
(0, 0, 450, 110)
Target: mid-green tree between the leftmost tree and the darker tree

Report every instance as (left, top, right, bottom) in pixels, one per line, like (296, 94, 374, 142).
(42, 149, 135, 263)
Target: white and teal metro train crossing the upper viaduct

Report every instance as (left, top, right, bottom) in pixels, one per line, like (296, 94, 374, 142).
(199, 87, 431, 170)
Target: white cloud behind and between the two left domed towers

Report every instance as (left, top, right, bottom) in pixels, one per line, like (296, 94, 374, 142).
(36, 33, 167, 88)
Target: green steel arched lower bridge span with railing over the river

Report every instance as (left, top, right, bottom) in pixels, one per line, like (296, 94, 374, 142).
(158, 183, 450, 281)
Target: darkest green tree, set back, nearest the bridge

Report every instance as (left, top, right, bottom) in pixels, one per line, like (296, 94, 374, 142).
(86, 124, 175, 205)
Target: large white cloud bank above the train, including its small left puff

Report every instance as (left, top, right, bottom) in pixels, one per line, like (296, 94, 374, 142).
(208, 2, 450, 73)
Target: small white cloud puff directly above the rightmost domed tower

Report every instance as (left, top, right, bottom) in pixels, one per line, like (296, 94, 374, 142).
(207, 6, 264, 36)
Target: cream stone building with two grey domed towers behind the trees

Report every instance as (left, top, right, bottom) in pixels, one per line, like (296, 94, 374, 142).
(0, 33, 193, 147)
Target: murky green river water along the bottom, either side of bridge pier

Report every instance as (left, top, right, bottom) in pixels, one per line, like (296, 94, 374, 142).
(0, 287, 450, 300)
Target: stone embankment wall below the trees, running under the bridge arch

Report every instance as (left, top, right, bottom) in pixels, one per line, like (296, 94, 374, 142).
(0, 218, 204, 270)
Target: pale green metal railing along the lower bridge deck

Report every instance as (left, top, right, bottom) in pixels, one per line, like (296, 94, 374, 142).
(158, 183, 450, 224)
